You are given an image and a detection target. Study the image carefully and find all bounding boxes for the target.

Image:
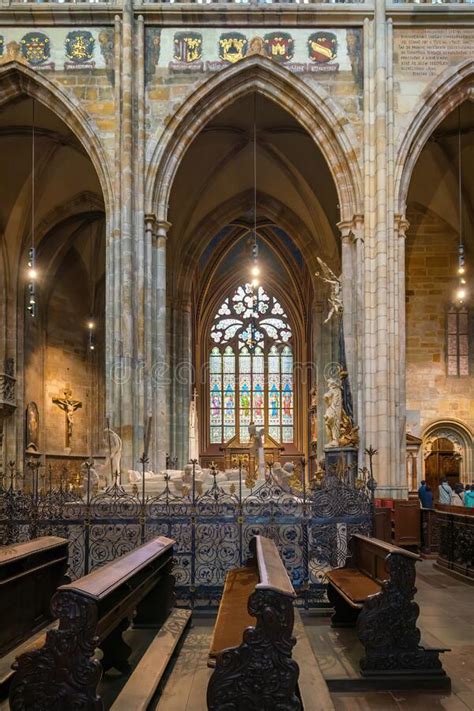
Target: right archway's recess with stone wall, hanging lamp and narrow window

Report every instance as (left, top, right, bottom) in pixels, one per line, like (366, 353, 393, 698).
(406, 98, 474, 490)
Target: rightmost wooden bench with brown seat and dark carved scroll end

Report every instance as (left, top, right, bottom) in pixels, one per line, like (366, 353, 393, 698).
(326, 534, 449, 688)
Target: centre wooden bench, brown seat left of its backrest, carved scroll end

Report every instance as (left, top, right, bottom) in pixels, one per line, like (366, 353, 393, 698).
(207, 536, 301, 711)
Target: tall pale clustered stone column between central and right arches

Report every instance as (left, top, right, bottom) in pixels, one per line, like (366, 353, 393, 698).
(364, 0, 406, 496)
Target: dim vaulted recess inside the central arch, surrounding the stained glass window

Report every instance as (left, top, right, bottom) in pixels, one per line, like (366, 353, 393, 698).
(167, 94, 341, 470)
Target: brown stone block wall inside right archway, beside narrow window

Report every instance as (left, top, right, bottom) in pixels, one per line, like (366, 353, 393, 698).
(406, 209, 474, 435)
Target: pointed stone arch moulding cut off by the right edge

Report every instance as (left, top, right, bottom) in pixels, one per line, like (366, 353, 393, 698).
(394, 60, 474, 215)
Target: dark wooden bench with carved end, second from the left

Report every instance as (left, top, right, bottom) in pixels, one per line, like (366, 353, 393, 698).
(10, 537, 188, 711)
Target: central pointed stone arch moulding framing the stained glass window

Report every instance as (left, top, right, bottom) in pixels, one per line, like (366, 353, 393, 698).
(145, 56, 362, 221)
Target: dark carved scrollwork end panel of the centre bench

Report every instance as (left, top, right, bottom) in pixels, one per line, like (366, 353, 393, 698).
(207, 590, 301, 711)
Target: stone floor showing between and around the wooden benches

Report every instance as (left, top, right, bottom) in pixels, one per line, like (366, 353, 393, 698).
(0, 561, 474, 711)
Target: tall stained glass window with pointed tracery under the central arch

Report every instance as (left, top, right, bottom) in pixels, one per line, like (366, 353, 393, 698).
(209, 284, 294, 444)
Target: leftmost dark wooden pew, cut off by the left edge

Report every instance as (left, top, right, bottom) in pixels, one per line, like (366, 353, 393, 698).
(0, 536, 68, 656)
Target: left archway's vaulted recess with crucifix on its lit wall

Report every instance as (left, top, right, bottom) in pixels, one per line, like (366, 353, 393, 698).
(0, 94, 105, 476)
